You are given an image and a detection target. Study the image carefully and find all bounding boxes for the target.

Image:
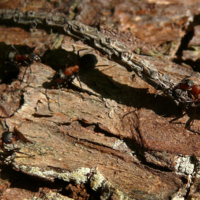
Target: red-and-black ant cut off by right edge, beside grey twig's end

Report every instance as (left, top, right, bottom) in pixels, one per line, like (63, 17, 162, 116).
(170, 77, 200, 129)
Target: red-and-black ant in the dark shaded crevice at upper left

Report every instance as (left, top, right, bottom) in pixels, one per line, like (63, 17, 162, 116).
(7, 45, 41, 73)
